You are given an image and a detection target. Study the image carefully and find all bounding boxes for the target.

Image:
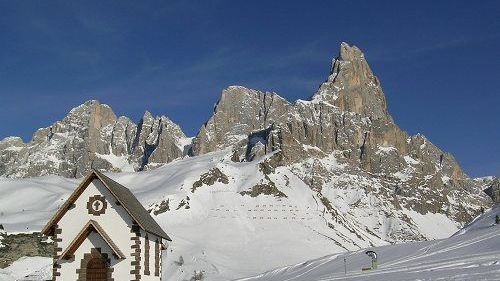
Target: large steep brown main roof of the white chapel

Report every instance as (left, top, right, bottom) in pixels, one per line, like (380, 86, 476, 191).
(42, 170, 172, 241)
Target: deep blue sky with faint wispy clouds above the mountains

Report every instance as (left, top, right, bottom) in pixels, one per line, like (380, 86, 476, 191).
(0, 0, 500, 176)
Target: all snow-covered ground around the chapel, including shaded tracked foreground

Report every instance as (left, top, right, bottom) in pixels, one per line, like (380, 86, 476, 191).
(0, 151, 500, 281)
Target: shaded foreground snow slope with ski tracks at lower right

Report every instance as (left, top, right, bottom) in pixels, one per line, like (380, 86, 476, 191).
(236, 207, 500, 281)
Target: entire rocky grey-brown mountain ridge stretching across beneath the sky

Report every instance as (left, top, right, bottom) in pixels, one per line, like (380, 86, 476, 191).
(0, 43, 492, 242)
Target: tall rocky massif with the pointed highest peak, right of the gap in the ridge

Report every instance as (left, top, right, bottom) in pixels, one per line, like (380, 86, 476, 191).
(192, 43, 488, 228)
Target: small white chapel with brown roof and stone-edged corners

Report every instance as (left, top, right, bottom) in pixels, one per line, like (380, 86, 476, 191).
(42, 170, 171, 281)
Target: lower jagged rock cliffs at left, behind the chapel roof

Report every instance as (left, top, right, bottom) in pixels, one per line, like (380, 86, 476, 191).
(0, 100, 185, 177)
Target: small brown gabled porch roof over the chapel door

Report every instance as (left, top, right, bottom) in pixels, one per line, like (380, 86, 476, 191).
(59, 220, 126, 259)
